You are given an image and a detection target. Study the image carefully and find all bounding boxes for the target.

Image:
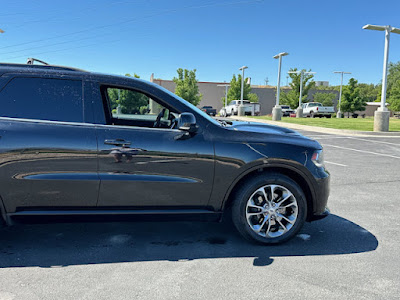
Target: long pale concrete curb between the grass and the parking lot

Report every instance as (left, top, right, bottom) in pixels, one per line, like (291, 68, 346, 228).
(230, 116, 400, 137)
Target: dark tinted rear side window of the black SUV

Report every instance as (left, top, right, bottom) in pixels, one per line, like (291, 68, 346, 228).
(0, 78, 83, 122)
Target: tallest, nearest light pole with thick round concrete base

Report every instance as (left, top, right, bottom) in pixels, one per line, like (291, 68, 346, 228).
(363, 24, 400, 131)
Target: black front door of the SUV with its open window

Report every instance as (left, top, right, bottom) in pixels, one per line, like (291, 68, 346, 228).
(91, 85, 214, 209)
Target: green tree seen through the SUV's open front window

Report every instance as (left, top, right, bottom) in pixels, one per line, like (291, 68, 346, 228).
(107, 74, 149, 114)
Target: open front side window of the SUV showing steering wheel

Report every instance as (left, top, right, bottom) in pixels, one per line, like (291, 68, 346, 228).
(103, 87, 175, 128)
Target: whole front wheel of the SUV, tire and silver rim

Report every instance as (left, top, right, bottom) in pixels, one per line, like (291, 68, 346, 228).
(232, 173, 307, 245)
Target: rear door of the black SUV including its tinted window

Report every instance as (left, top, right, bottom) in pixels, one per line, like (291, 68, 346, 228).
(0, 75, 99, 213)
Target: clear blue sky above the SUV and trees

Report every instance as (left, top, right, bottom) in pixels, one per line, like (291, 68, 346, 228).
(0, 0, 400, 85)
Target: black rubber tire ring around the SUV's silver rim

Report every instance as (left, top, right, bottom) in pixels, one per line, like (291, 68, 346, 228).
(232, 173, 307, 245)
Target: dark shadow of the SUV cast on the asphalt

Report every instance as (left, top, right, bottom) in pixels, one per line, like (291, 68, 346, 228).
(0, 215, 378, 268)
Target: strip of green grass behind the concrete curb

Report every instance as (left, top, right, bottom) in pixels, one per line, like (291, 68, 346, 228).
(253, 116, 400, 131)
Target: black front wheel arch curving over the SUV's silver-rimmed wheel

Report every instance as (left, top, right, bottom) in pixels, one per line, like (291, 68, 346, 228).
(222, 163, 315, 221)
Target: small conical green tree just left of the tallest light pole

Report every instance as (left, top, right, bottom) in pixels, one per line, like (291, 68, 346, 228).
(338, 78, 367, 117)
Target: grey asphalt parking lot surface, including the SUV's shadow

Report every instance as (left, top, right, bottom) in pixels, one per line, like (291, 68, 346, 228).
(0, 127, 400, 300)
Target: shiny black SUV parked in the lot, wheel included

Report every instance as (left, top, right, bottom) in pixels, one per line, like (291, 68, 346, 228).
(0, 64, 329, 244)
